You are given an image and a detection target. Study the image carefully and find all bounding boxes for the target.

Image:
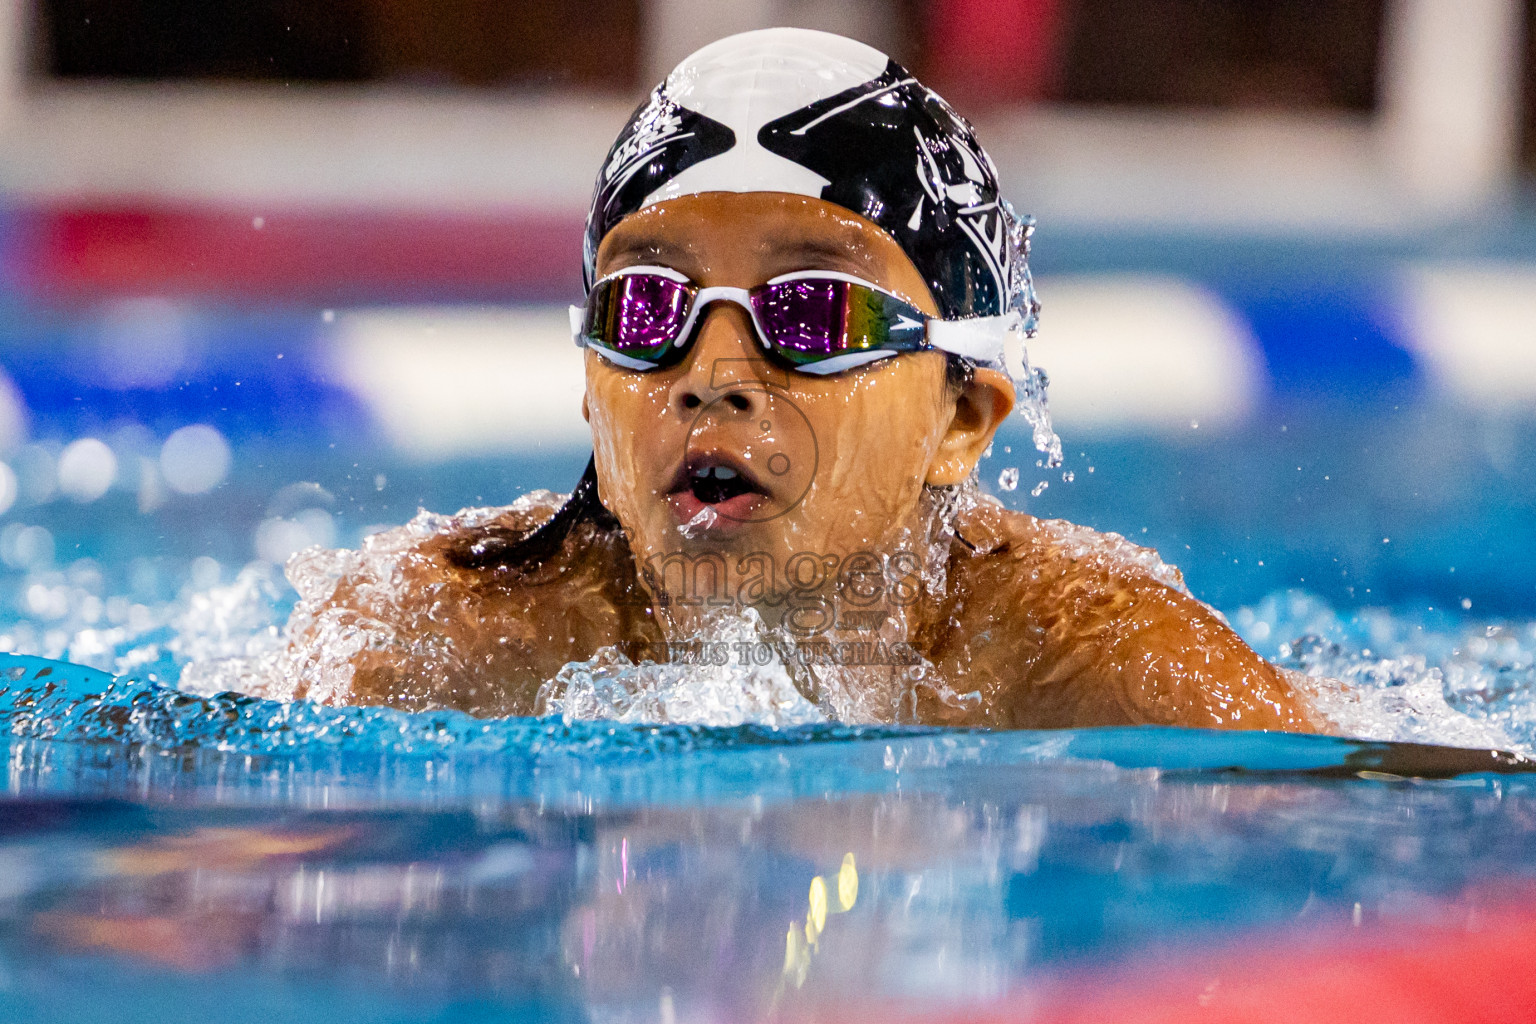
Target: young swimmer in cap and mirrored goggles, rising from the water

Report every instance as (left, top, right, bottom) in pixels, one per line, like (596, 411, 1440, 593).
(275, 29, 1316, 731)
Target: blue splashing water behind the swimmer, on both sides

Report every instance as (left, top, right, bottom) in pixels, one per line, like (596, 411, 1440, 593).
(0, 404, 1536, 752)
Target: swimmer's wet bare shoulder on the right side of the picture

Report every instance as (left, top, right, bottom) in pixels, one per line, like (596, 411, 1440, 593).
(921, 504, 1313, 731)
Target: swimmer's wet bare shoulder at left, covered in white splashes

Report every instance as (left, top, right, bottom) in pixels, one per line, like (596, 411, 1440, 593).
(286, 491, 642, 714)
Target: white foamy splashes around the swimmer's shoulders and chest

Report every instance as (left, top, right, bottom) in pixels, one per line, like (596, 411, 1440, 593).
(0, 506, 1536, 752)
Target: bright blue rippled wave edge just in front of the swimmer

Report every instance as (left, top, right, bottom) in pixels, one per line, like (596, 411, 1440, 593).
(0, 656, 1533, 806)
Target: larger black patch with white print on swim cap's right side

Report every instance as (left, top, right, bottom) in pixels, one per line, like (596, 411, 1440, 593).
(757, 61, 1009, 318)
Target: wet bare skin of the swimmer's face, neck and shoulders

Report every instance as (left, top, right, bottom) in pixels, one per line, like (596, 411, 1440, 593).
(290, 193, 1316, 731)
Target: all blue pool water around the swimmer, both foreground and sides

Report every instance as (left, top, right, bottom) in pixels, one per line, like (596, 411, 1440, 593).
(0, 284, 1536, 1024)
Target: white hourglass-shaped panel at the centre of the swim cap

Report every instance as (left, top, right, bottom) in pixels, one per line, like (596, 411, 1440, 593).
(642, 29, 889, 206)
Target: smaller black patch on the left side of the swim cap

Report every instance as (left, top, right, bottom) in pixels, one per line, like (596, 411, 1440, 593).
(584, 90, 736, 286)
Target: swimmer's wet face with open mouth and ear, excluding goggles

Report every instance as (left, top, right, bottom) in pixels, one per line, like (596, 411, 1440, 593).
(582, 192, 1012, 607)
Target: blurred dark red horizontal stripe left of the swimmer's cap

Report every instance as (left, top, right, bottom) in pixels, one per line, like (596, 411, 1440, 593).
(18, 204, 582, 302)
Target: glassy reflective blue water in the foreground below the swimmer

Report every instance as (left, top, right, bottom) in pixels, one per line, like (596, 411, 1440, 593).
(0, 656, 1536, 1021)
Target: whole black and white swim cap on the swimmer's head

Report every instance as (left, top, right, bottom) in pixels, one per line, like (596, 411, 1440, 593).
(584, 29, 1035, 364)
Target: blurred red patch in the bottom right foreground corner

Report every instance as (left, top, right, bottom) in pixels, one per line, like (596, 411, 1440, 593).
(786, 900, 1536, 1024)
